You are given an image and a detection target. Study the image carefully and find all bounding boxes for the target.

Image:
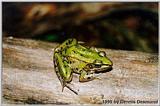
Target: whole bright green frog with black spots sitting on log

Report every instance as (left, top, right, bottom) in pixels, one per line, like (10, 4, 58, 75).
(53, 38, 113, 94)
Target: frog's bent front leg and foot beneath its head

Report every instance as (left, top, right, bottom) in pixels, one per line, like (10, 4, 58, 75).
(79, 71, 99, 82)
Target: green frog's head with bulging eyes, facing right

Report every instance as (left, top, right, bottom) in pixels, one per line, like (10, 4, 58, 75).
(88, 51, 113, 72)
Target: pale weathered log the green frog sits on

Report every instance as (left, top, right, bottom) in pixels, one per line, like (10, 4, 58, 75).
(2, 37, 158, 104)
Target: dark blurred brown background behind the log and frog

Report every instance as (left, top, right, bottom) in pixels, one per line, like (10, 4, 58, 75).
(3, 2, 158, 53)
